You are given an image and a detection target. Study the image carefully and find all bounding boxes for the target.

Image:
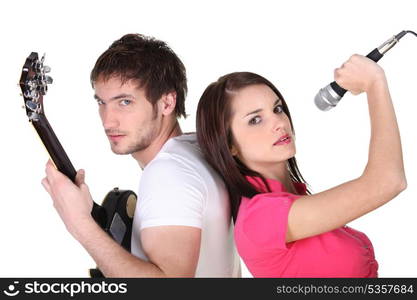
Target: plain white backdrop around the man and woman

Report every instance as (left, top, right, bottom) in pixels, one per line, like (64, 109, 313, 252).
(0, 0, 417, 277)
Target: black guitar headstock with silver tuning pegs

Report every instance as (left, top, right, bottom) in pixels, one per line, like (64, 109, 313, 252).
(19, 52, 52, 121)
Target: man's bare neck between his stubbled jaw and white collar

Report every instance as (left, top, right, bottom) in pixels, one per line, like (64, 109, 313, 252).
(132, 120, 182, 169)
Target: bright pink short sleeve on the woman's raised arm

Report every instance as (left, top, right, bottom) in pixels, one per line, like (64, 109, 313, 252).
(235, 192, 297, 256)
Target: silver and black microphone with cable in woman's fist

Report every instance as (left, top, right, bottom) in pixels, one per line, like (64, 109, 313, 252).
(314, 30, 408, 111)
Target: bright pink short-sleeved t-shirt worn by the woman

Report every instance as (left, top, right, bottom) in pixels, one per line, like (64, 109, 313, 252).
(234, 177, 378, 277)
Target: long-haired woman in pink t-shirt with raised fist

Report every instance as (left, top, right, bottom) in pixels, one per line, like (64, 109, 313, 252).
(197, 55, 406, 277)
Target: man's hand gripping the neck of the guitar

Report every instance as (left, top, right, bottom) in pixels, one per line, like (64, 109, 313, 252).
(42, 160, 94, 239)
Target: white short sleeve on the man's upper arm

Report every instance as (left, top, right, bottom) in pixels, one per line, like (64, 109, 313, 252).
(135, 154, 207, 230)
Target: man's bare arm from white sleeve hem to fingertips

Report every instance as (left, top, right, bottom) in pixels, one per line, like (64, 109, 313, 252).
(42, 161, 201, 277)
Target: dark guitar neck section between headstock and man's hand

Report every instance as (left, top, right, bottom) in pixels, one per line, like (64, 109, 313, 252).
(32, 115, 77, 182)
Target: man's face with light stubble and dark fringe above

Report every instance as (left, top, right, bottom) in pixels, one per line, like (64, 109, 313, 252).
(94, 77, 161, 154)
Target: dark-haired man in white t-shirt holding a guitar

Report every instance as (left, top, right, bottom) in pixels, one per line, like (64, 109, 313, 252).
(42, 34, 240, 277)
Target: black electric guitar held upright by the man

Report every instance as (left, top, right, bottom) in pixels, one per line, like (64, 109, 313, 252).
(19, 52, 137, 278)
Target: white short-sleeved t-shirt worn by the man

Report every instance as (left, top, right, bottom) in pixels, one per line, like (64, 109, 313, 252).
(131, 134, 240, 277)
